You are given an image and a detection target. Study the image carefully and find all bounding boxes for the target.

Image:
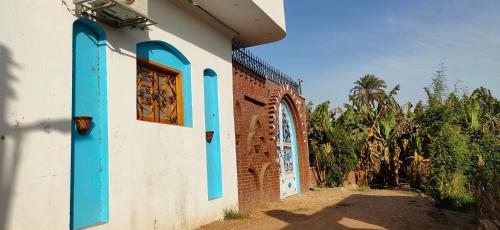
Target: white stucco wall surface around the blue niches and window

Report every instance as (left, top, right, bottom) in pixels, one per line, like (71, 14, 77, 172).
(0, 0, 238, 230)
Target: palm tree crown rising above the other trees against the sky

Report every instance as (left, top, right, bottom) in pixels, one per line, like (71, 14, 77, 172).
(350, 74, 387, 110)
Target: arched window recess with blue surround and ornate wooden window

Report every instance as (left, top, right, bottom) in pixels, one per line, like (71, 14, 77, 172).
(137, 41, 193, 127)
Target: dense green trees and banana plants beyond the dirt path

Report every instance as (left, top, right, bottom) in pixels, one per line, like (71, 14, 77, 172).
(308, 68, 500, 215)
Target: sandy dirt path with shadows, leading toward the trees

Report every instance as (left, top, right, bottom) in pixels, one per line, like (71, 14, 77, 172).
(200, 188, 475, 230)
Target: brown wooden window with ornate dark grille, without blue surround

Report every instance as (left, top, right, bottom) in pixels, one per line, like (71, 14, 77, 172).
(137, 59, 183, 125)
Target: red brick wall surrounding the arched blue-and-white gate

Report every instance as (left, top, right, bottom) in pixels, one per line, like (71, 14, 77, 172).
(233, 62, 310, 211)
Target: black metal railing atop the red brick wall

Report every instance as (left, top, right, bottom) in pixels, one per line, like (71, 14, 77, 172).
(233, 49, 301, 92)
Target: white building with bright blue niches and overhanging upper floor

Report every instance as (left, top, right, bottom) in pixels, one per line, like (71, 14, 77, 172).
(0, 0, 285, 230)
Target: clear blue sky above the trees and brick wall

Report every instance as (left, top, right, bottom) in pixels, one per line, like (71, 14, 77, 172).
(251, 0, 500, 107)
